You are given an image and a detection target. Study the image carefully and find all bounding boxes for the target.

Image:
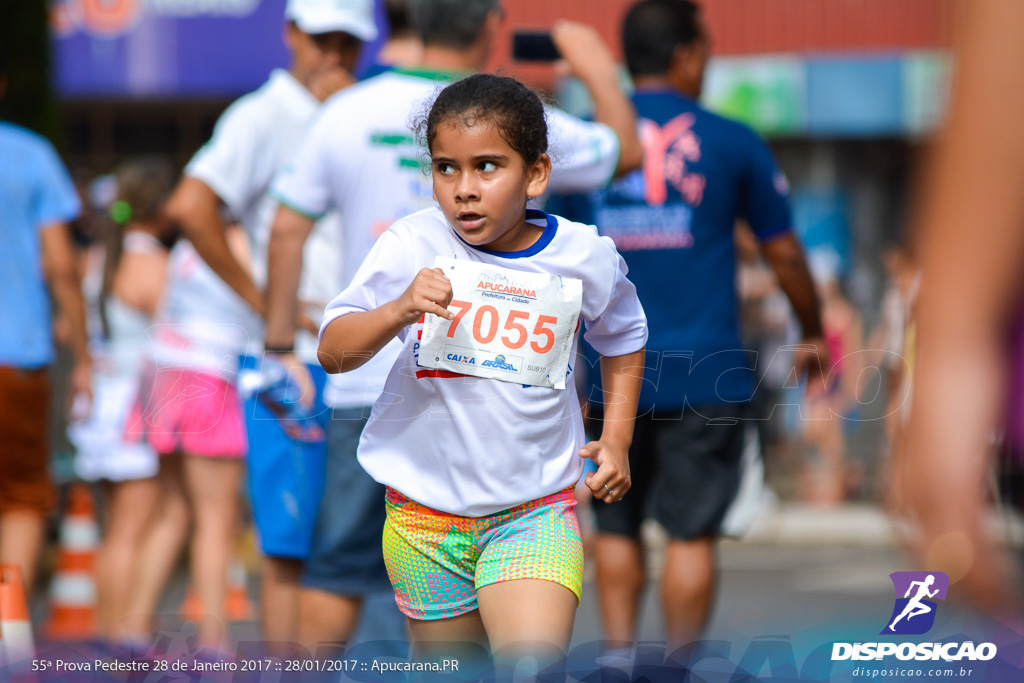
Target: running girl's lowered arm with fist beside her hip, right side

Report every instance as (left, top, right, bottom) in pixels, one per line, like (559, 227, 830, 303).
(580, 349, 644, 503)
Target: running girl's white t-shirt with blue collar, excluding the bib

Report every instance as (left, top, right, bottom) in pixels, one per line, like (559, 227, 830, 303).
(321, 207, 647, 517)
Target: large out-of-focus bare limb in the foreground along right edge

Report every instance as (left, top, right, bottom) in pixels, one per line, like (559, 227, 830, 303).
(901, 0, 1024, 614)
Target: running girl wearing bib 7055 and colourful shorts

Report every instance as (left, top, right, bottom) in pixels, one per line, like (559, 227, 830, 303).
(319, 75, 647, 665)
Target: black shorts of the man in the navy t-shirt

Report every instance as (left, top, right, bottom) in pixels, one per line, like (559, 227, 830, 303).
(589, 404, 748, 541)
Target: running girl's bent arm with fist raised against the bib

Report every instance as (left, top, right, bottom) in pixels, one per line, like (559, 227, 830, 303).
(316, 268, 455, 374)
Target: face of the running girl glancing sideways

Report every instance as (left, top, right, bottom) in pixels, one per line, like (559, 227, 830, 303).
(430, 120, 551, 252)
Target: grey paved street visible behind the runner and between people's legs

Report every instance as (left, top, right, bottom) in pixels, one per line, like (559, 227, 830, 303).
(25, 505, 1015, 680)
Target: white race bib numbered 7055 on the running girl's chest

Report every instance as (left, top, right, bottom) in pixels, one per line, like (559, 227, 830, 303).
(417, 256, 583, 389)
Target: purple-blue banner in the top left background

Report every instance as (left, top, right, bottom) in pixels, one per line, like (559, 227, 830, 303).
(51, 0, 383, 98)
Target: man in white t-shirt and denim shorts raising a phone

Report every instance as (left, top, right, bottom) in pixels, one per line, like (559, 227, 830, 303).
(266, 0, 642, 643)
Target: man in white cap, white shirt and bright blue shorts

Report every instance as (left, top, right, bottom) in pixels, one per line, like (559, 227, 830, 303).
(163, 0, 377, 642)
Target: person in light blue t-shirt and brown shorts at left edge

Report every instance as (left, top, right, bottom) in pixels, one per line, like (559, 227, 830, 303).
(0, 46, 92, 592)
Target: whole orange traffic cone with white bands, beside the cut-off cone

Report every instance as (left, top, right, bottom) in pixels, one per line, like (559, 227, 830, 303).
(46, 484, 99, 640)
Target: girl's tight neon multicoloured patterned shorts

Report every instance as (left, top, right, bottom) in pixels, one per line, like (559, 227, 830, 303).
(384, 487, 583, 620)
